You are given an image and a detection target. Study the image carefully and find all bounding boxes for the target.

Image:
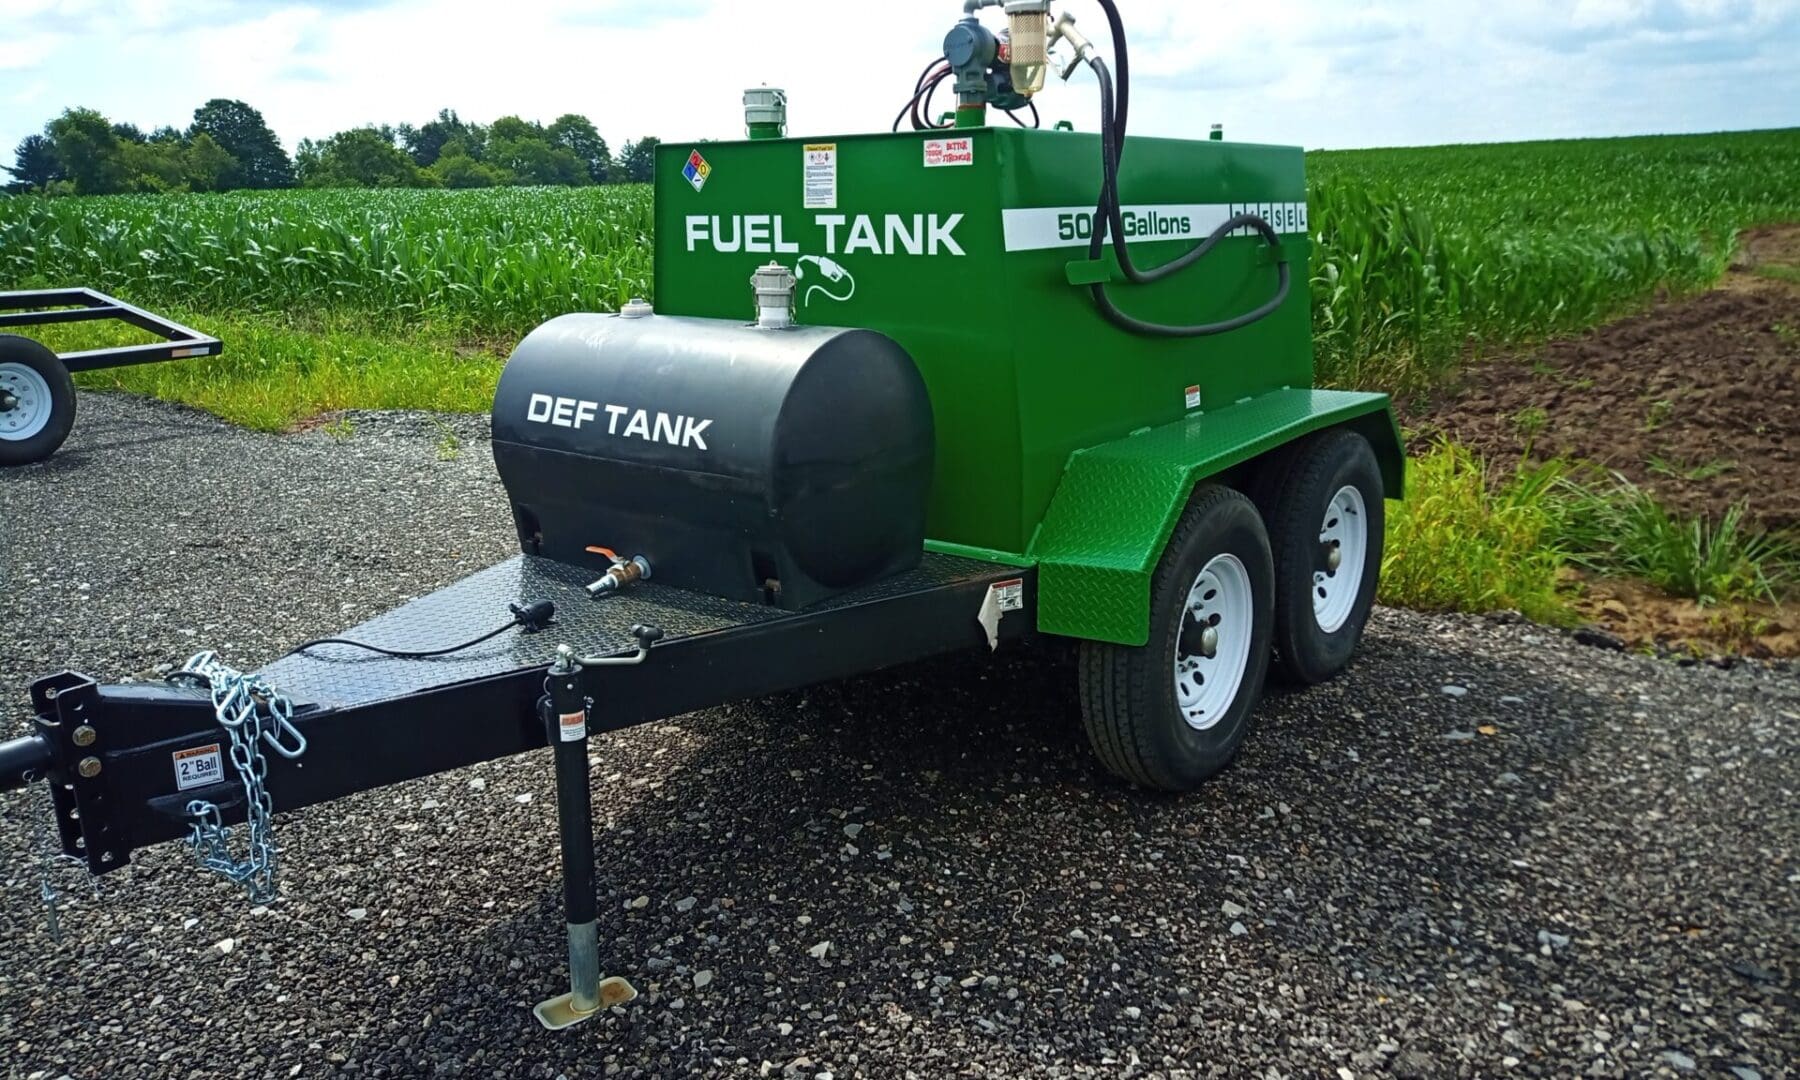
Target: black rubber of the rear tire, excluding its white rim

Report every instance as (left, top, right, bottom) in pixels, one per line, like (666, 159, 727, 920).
(1258, 428, 1388, 686)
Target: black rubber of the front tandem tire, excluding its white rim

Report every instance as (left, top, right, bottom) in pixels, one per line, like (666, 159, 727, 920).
(1080, 486, 1274, 792)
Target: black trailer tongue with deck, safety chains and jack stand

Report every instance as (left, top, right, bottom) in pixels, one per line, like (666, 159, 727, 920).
(0, 554, 1035, 1021)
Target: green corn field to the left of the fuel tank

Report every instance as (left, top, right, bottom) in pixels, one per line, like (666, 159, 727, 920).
(0, 185, 652, 333)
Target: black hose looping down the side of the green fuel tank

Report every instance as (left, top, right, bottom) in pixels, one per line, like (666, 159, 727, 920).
(1087, 0, 1292, 338)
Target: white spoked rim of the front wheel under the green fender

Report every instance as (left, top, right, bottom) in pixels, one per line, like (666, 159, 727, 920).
(1175, 554, 1256, 731)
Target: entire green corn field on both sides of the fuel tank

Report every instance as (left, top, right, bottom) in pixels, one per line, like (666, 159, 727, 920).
(0, 130, 1800, 389)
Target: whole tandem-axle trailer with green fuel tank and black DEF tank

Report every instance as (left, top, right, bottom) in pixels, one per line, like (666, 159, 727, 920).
(0, 0, 1404, 1028)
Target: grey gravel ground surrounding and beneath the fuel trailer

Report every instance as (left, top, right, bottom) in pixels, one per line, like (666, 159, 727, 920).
(0, 394, 1800, 1078)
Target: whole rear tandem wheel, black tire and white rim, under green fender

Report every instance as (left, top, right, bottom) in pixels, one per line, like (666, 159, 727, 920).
(1264, 428, 1386, 686)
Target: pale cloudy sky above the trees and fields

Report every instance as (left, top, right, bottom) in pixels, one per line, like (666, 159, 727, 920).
(0, 0, 1800, 162)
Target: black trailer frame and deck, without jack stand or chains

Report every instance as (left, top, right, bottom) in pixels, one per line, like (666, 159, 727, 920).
(0, 554, 1037, 875)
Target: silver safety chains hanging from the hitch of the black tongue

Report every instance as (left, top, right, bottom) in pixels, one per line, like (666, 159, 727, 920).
(169, 652, 306, 904)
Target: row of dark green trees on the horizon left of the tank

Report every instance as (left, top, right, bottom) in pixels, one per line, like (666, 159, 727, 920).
(0, 97, 661, 194)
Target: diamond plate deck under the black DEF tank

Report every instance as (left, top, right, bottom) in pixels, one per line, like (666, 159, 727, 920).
(261, 553, 1019, 709)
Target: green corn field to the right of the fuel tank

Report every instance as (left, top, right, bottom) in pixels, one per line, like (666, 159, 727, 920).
(1307, 130, 1800, 389)
